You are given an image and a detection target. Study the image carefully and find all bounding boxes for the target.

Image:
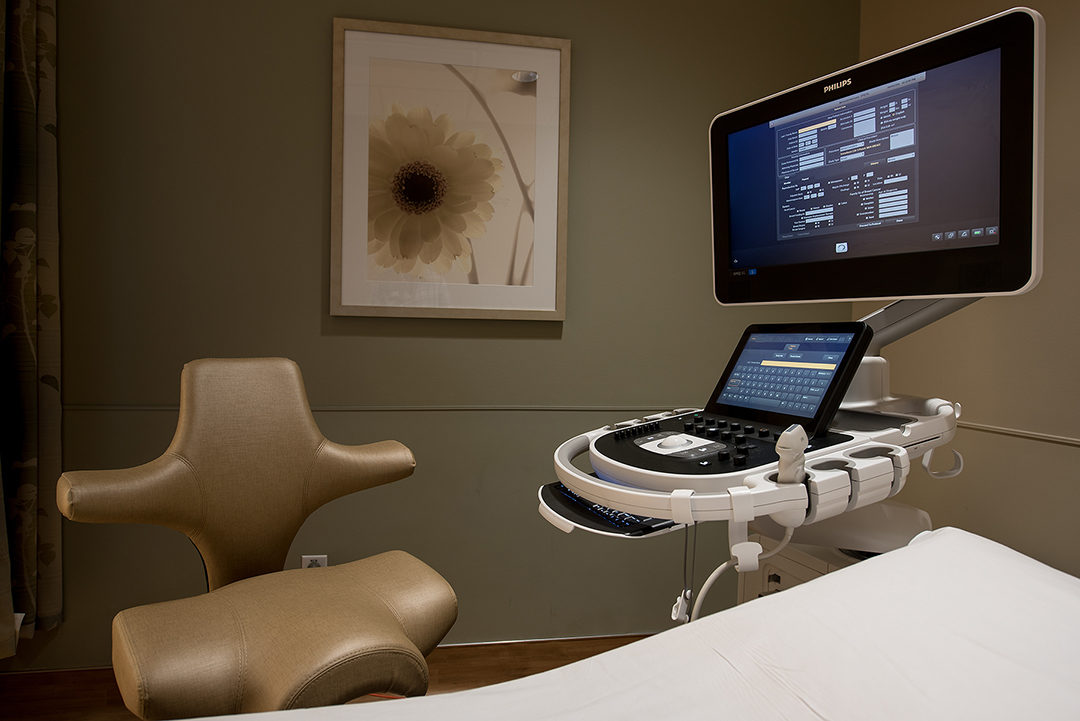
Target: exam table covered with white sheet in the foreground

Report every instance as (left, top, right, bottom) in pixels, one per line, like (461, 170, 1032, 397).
(196, 528, 1080, 721)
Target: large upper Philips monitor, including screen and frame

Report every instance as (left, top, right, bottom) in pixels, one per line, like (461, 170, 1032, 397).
(710, 9, 1043, 304)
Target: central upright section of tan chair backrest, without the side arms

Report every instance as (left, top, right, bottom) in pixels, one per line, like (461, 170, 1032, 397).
(166, 358, 325, 589)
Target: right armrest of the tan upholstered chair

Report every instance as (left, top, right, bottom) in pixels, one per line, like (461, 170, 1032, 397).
(303, 440, 416, 514)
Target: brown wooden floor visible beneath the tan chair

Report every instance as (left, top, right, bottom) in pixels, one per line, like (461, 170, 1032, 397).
(0, 636, 643, 721)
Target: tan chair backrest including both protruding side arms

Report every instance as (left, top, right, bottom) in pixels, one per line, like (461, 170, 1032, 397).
(56, 358, 415, 590)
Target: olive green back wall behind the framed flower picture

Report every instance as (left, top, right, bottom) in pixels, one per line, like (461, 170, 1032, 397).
(0, 0, 859, 670)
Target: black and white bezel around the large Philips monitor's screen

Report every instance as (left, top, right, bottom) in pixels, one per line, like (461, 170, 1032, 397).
(710, 9, 1044, 304)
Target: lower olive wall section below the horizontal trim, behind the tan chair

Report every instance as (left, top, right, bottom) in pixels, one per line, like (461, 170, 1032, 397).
(0, 409, 735, 670)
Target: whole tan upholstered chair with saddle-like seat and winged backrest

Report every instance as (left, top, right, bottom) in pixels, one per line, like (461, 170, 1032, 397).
(56, 358, 457, 719)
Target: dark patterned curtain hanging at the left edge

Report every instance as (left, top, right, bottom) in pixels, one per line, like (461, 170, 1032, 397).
(0, 0, 63, 657)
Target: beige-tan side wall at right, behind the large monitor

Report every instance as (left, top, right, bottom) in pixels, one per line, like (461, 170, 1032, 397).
(858, 0, 1080, 574)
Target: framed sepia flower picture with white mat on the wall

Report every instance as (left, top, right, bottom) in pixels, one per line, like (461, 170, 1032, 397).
(330, 18, 570, 321)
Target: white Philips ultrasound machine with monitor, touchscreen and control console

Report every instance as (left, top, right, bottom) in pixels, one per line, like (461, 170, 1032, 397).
(539, 9, 1044, 621)
